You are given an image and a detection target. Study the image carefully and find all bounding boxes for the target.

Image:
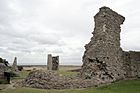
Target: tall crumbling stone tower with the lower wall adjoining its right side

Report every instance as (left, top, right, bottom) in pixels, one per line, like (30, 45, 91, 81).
(81, 7, 140, 83)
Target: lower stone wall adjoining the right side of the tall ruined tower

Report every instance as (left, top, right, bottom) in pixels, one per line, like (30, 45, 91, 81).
(124, 51, 140, 78)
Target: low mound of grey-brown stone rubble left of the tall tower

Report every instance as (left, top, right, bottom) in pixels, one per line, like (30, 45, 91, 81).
(18, 70, 98, 89)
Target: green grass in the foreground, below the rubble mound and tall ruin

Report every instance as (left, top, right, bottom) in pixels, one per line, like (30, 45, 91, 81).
(0, 80, 140, 93)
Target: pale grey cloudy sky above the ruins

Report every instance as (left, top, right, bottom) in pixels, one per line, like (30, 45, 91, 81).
(0, 0, 140, 65)
